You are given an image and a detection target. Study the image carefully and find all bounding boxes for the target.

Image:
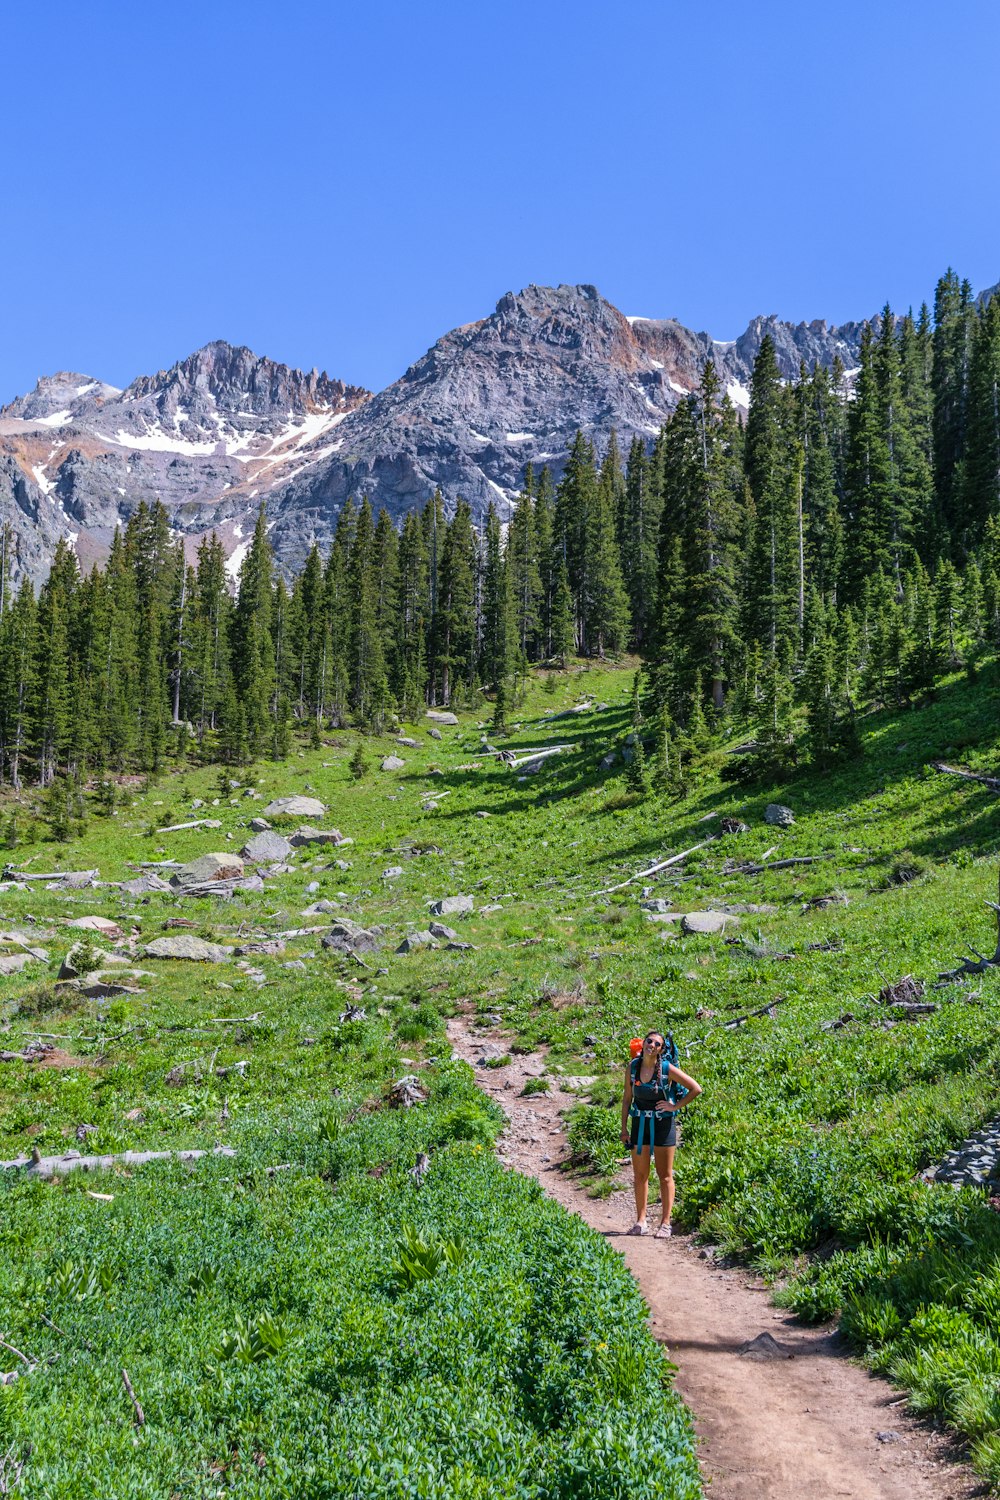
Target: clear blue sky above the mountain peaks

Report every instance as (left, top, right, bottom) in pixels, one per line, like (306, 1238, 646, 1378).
(0, 0, 1000, 402)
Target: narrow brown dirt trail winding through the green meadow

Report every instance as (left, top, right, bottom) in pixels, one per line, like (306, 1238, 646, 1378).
(448, 1016, 988, 1500)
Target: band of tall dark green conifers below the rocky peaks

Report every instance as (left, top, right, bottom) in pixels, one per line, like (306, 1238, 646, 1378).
(0, 272, 1000, 786)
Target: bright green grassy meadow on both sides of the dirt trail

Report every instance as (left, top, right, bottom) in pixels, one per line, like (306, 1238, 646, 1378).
(0, 665, 1000, 1500)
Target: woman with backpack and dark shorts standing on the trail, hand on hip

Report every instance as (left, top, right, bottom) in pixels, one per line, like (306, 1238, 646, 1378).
(622, 1032, 702, 1239)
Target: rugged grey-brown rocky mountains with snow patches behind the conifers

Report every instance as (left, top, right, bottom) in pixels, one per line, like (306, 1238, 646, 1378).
(0, 285, 861, 578)
